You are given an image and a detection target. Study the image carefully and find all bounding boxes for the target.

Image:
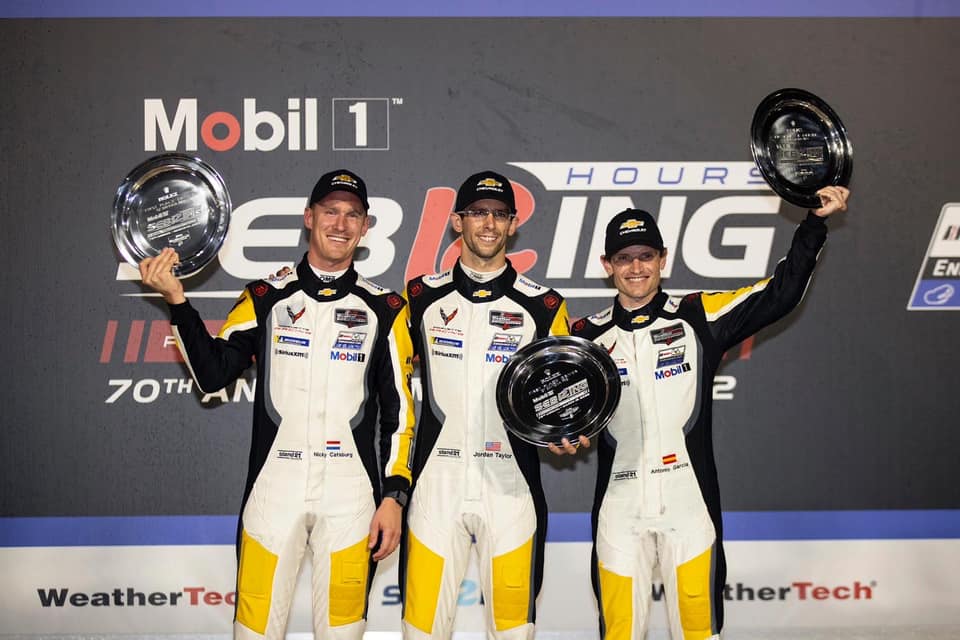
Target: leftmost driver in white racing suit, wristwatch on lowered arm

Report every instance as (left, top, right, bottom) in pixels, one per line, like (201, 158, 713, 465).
(140, 170, 413, 640)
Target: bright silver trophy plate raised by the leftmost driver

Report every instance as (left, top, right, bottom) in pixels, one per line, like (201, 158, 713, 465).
(110, 153, 232, 278)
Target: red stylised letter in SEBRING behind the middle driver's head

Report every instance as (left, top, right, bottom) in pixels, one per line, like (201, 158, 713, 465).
(403, 180, 537, 282)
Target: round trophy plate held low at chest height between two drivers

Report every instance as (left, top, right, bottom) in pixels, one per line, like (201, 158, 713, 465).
(497, 336, 620, 447)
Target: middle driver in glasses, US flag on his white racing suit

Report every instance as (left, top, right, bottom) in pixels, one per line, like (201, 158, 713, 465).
(400, 171, 573, 640)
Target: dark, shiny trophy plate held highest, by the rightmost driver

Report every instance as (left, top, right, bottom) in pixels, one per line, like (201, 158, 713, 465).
(750, 89, 853, 209)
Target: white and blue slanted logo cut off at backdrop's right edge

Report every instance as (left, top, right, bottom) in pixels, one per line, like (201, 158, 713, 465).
(907, 202, 960, 311)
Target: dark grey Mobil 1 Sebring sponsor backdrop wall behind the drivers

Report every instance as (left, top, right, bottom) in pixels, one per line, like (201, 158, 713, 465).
(0, 2, 960, 634)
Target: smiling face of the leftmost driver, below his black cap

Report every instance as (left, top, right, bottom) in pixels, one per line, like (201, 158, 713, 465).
(303, 191, 370, 271)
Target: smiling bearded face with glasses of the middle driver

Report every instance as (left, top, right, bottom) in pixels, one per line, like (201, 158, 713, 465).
(450, 199, 517, 271)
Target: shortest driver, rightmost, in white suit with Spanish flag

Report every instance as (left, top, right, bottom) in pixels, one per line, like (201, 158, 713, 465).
(572, 186, 849, 640)
